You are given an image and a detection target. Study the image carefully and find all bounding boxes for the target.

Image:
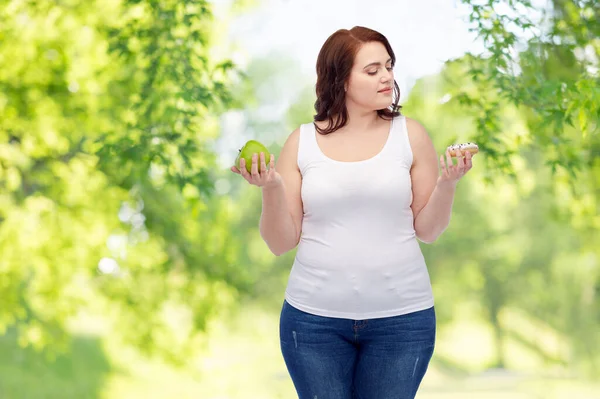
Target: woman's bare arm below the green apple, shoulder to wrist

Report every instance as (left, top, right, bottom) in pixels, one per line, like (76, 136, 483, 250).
(260, 129, 303, 256)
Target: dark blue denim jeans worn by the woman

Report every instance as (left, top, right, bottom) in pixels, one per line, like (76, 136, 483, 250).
(279, 300, 436, 399)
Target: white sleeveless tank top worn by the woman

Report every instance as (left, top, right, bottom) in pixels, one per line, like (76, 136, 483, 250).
(285, 116, 433, 320)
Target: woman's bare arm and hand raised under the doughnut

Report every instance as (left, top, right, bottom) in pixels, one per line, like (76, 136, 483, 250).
(406, 118, 470, 243)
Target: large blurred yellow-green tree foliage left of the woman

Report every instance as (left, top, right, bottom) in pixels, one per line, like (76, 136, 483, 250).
(0, 0, 252, 360)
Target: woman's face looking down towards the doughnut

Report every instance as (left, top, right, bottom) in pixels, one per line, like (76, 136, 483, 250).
(346, 42, 394, 110)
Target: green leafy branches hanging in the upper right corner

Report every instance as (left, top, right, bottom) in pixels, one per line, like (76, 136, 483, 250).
(458, 0, 600, 179)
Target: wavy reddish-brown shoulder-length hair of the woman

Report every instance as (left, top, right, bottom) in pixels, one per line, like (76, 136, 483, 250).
(314, 26, 402, 134)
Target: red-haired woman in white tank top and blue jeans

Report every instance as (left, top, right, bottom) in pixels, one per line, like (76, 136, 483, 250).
(232, 27, 472, 399)
